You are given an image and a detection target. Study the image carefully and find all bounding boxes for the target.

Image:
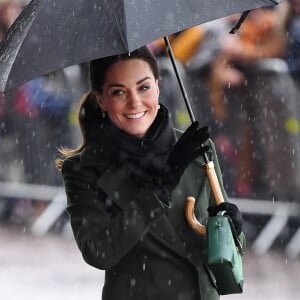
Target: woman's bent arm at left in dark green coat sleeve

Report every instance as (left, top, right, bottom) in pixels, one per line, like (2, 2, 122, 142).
(62, 158, 166, 269)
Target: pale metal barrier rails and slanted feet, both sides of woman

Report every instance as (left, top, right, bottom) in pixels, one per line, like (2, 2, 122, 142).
(0, 182, 300, 259)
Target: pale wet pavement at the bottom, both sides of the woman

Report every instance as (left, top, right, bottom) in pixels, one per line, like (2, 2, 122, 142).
(0, 225, 300, 300)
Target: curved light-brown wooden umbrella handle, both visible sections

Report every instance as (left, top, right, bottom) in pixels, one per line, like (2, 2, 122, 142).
(185, 161, 224, 235)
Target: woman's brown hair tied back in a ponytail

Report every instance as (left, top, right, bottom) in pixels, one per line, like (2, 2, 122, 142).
(55, 46, 159, 170)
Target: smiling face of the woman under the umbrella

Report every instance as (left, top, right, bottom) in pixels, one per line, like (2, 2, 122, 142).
(97, 59, 159, 138)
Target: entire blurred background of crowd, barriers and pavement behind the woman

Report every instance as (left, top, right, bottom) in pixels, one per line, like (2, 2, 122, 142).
(0, 0, 300, 300)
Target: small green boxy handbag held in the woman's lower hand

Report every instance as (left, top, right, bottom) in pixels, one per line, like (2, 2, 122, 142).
(207, 212, 244, 295)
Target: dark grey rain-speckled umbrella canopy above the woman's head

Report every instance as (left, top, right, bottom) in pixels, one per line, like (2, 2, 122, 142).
(0, 0, 280, 92)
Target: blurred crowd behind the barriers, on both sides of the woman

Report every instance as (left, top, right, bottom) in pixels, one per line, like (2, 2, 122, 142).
(0, 0, 300, 223)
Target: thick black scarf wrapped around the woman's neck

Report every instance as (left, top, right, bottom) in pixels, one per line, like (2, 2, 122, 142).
(89, 105, 176, 177)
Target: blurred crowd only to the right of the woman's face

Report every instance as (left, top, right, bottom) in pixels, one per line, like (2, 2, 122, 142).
(151, 0, 300, 201)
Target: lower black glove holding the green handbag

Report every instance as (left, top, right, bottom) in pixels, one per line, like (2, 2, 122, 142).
(207, 202, 243, 235)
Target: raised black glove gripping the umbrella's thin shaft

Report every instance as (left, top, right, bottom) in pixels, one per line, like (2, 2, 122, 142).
(160, 121, 210, 191)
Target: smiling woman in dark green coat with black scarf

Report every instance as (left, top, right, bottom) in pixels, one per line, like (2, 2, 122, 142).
(57, 47, 244, 300)
